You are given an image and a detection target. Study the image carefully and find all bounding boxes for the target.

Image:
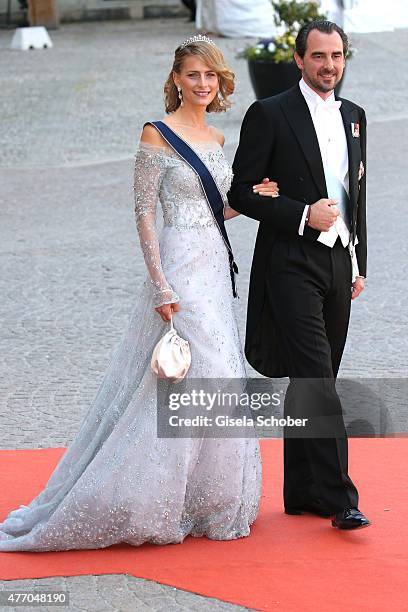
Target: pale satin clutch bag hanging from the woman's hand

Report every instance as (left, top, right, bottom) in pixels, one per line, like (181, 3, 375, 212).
(151, 317, 191, 383)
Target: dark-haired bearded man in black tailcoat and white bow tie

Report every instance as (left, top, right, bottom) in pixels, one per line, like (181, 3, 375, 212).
(228, 21, 370, 529)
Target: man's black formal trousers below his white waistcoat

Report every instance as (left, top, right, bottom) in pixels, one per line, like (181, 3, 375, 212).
(266, 235, 358, 512)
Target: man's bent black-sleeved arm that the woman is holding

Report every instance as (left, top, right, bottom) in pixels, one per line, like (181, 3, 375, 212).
(228, 102, 305, 234)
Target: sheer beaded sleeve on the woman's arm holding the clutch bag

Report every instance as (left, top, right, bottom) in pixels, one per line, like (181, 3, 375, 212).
(133, 143, 180, 308)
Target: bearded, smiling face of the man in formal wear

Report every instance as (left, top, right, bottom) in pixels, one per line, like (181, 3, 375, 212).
(295, 30, 346, 94)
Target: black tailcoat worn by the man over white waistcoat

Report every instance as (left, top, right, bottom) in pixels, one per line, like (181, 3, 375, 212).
(228, 85, 367, 377)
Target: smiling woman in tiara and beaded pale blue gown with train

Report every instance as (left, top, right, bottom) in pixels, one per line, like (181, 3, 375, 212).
(0, 33, 276, 551)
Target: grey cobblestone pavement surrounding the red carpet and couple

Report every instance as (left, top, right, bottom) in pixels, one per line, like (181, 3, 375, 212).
(0, 20, 408, 610)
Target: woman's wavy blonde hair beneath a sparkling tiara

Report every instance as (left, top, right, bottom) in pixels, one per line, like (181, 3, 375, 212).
(164, 41, 235, 113)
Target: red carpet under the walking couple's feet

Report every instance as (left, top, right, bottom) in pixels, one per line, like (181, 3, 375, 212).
(0, 439, 408, 612)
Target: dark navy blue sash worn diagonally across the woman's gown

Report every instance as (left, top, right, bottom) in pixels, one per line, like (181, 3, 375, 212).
(145, 121, 238, 297)
